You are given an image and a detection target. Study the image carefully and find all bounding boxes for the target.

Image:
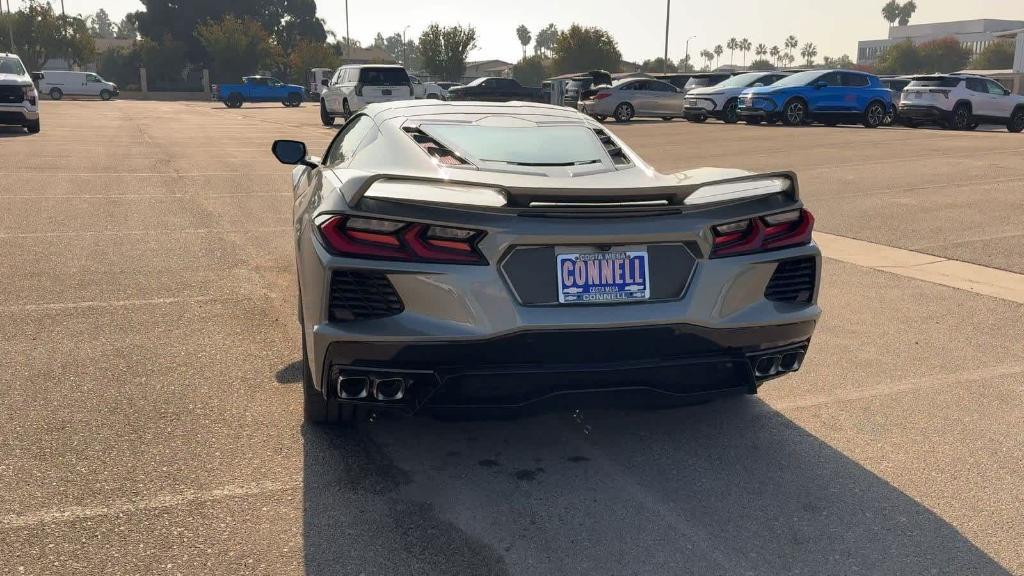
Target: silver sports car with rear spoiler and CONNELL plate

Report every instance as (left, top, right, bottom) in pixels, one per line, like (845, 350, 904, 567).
(273, 100, 821, 422)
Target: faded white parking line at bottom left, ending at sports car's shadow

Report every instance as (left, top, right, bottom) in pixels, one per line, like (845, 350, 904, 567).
(0, 481, 302, 528)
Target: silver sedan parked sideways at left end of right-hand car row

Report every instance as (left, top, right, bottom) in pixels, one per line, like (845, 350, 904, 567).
(577, 78, 685, 122)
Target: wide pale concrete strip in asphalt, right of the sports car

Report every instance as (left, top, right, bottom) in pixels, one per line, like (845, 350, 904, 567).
(814, 233, 1024, 304)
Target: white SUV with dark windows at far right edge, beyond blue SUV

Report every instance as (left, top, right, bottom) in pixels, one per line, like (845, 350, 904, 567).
(899, 74, 1024, 132)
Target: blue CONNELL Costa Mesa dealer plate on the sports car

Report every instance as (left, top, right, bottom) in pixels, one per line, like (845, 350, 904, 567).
(556, 250, 650, 304)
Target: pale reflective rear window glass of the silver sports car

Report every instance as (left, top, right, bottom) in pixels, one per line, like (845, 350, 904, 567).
(420, 124, 605, 166)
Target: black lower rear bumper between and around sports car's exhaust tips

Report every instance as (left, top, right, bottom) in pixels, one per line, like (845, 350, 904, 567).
(324, 321, 815, 413)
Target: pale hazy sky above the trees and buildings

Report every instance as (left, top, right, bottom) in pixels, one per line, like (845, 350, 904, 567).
(44, 0, 1024, 64)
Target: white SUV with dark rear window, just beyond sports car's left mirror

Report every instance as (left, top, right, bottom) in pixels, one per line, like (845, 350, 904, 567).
(321, 64, 414, 126)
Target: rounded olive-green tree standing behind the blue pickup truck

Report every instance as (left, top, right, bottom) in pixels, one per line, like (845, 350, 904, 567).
(196, 15, 281, 82)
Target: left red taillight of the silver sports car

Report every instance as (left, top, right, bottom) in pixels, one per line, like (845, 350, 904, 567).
(319, 216, 487, 265)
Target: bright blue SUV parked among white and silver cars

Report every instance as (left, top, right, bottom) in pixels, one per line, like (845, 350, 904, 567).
(738, 70, 893, 128)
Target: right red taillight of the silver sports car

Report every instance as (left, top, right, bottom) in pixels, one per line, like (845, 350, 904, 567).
(711, 209, 814, 258)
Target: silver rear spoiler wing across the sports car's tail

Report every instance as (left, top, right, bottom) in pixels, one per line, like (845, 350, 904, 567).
(348, 171, 800, 213)
